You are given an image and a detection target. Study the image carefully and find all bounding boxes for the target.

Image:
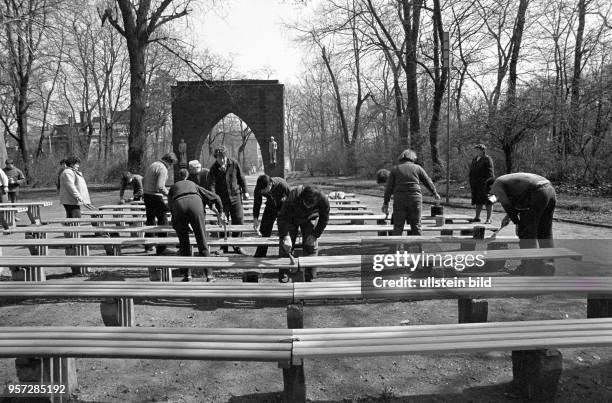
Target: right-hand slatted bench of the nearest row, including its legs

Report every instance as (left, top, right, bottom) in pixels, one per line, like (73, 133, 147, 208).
(289, 319, 612, 402)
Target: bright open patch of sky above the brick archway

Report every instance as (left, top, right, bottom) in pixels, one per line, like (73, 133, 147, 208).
(192, 0, 303, 83)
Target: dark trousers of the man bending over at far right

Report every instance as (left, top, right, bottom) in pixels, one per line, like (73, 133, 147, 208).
(517, 184, 557, 270)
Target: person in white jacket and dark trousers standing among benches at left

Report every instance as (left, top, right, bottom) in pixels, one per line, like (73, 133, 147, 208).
(60, 157, 94, 218)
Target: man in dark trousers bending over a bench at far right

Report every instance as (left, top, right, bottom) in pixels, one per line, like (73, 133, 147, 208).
(487, 172, 557, 275)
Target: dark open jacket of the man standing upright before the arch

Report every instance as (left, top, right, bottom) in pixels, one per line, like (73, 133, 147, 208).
(207, 158, 248, 206)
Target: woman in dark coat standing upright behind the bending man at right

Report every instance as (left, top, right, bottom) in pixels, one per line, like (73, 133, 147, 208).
(470, 144, 495, 224)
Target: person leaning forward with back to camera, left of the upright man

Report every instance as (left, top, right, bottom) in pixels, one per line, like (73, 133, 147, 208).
(168, 169, 223, 282)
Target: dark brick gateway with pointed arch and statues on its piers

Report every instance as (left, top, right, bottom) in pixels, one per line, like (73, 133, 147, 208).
(172, 80, 285, 177)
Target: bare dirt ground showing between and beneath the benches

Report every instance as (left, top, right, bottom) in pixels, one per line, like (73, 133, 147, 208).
(0, 181, 612, 403)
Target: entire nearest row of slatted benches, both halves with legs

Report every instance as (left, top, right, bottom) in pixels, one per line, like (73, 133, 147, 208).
(0, 318, 612, 402)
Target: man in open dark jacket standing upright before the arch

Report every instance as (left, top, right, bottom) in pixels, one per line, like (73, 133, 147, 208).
(207, 146, 249, 253)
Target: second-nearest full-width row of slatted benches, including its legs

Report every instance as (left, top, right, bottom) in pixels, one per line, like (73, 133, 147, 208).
(0, 276, 612, 326)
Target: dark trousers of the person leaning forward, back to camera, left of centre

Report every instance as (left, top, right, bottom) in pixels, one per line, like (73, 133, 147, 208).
(172, 195, 212, 277)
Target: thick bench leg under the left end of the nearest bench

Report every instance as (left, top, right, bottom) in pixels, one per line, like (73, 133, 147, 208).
(15, 357, 78, 403)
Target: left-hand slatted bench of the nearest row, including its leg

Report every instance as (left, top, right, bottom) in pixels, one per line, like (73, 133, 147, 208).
(0, 326, 292, 402)
